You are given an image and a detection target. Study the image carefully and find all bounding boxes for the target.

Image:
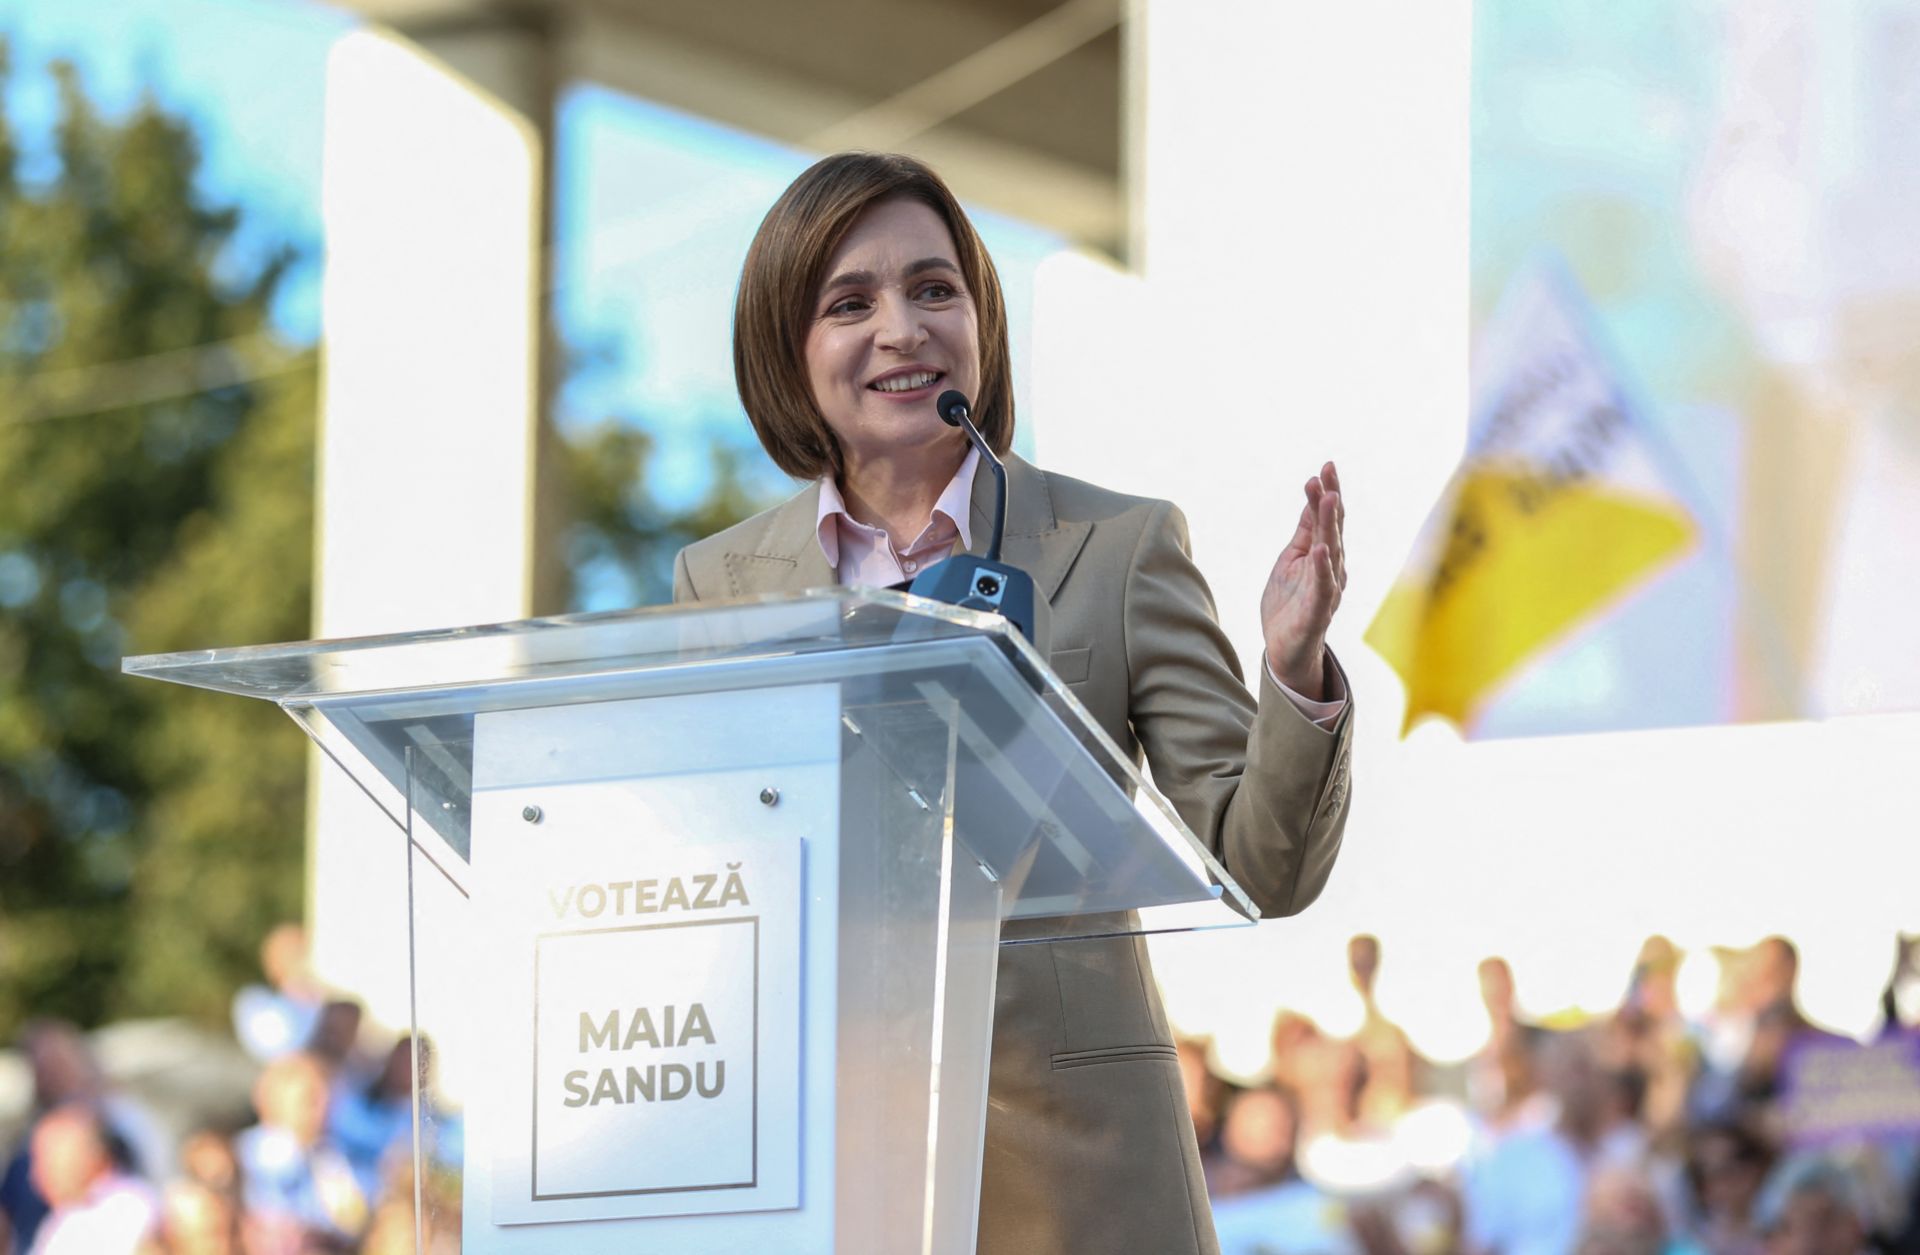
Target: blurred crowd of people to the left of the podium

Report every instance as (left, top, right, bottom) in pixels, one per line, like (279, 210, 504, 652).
(0, 925, 459, 1255)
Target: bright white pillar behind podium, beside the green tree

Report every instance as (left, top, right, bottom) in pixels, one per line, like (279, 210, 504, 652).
(309, 33, 543, 1025)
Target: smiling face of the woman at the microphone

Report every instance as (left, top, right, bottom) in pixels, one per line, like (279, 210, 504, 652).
(806, 200, 979, 464)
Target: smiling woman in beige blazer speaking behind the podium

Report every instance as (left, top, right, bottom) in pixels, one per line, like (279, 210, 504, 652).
(674, 154, 1352, 1255)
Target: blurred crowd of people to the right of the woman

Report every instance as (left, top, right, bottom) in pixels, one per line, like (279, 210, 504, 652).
(1181, 936, 1920, 1255)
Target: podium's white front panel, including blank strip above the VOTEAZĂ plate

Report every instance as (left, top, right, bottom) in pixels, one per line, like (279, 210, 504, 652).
(468, 685, 839, 1224)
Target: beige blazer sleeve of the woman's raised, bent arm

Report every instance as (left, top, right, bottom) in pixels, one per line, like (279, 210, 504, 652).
(1123, 501, 1354, 915)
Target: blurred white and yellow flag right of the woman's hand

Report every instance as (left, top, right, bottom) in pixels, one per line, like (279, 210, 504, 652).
(1365, 263, 1697, 735)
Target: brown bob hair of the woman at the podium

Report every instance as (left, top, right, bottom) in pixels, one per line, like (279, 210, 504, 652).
(733, 152, 1014, 480)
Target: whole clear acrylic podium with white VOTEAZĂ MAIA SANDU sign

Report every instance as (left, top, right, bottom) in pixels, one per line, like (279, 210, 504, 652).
(125, 589, 1258, 1255)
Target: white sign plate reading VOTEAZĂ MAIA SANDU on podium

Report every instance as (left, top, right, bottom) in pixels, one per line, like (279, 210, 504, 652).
(474, 756, 803, 1224)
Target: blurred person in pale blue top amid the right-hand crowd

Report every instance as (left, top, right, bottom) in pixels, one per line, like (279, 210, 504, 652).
(1465, 1030, 1634, 1255)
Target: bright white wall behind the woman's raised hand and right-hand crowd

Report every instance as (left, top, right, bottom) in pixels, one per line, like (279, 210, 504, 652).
(1033, 0, 1920, 1069)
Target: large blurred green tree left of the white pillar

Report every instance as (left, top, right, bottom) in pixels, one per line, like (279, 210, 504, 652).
(0, 44, 315, 1036)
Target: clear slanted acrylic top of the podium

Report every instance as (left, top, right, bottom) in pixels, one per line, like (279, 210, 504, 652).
(123, 587, 1260, 931)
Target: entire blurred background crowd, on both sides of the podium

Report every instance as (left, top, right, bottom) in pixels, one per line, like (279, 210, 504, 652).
(0, 925, 1920, 1255)
